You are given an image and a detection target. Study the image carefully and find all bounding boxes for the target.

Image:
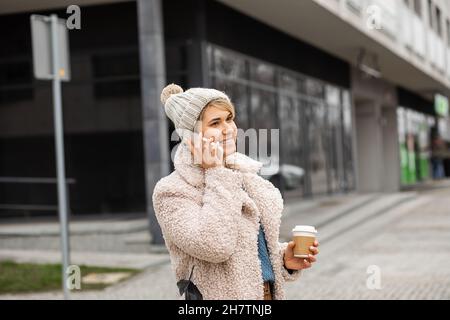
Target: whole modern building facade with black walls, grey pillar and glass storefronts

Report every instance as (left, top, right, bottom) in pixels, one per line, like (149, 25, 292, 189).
(0, 0, 450, 242)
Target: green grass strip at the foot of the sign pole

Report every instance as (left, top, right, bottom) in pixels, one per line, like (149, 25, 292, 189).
(0, 261, 139, 294)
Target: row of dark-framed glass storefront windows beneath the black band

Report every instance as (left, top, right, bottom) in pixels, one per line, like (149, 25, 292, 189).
(206, 44, 355, 198)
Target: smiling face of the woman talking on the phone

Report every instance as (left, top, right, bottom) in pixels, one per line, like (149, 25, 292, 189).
(202, 105, 237, 157)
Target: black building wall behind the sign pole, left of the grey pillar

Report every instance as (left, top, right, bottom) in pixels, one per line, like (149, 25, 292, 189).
(0, 2, 146, 216)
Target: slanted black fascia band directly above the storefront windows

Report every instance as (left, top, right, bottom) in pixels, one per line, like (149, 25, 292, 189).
(205, 1, 350, 88)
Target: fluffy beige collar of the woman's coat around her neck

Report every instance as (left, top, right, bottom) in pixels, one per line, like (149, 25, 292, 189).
(174, 142, 262, 186)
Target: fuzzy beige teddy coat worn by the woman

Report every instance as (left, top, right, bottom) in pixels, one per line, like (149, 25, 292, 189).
(153, 143, 300, 300)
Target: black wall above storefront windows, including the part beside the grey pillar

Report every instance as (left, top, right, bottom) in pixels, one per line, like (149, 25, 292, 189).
(163, 0, 350, 88)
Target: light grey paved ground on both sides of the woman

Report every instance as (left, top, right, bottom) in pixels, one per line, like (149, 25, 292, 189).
(0, 182, 450, 299)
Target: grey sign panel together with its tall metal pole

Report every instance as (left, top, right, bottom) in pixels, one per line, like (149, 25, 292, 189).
(30, 14, 70, 299)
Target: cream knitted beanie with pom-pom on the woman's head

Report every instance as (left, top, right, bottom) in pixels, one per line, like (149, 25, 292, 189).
(161, 83, 230, 137)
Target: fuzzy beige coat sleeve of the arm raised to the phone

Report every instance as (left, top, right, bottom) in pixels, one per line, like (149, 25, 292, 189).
(153, 167, 242, 263)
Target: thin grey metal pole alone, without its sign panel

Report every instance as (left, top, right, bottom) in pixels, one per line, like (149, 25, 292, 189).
(50, 14, 70, 299)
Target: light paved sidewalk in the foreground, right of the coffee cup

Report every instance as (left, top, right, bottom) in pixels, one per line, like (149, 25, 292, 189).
(287, 188, 450, 300)
